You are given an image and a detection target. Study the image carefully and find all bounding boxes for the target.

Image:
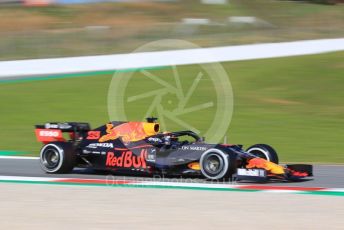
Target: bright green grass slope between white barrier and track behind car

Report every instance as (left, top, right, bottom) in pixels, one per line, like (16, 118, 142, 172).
(0, 52, 344, 163)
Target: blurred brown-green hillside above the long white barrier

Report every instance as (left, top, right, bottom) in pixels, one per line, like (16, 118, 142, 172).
(0, 0, 344, 60)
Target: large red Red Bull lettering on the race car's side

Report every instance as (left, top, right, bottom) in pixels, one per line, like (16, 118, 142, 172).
(105, 149, 147, 169)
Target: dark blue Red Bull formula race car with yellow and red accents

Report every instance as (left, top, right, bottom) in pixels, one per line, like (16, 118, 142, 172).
(35, 118, 312, 181)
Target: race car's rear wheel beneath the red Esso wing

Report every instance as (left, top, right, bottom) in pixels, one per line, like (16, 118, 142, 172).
(40, 142, 76, 173)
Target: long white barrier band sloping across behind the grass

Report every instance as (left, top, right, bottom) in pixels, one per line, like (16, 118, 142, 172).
(0, 38, 344, 78)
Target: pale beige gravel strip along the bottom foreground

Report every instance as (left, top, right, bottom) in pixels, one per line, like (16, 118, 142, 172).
(0, 183, 344, 230)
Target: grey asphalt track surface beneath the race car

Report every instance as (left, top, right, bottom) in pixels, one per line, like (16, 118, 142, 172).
(0, 158, 344, 188)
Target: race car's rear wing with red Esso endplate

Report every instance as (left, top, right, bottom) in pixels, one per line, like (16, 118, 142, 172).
(35, 122, 91, 144)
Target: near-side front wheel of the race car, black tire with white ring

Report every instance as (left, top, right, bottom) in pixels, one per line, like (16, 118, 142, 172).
(200, 148, 236, 180)
